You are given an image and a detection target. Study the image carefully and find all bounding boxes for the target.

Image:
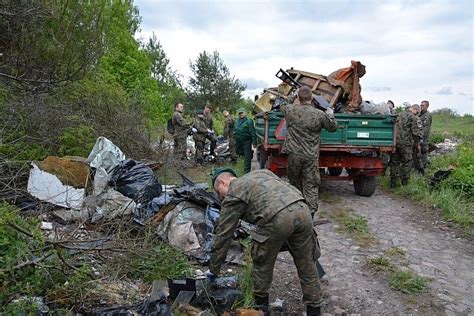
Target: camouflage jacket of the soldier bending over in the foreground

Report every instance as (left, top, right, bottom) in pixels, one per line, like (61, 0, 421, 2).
(209, 169, 303, 275)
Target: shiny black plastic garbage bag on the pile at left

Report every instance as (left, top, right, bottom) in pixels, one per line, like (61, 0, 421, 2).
(108, 159, 162, 203)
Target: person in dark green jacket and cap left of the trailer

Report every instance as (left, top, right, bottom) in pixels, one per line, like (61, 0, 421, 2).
(234, 108, 257, 172)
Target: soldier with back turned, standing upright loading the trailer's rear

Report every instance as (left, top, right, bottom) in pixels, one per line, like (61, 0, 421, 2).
(281, 87, 337, 215)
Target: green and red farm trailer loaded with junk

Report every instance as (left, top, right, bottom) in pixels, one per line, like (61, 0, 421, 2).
(255, 111, 396, 196)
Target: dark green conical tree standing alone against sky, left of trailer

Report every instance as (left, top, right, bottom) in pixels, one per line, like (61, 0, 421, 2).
(187, 51, 245, 110)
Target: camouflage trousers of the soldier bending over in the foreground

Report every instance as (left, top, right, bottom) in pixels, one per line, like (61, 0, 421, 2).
(251, 201, 321, 306)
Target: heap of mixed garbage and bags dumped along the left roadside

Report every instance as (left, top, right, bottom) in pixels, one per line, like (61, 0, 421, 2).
(22, 137, 260, 315)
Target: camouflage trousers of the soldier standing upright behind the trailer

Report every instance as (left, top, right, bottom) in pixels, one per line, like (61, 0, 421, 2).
(286, 154, 321, 214)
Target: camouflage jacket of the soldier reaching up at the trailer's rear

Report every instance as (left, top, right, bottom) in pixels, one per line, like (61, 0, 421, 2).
(281, 102, 337, 158)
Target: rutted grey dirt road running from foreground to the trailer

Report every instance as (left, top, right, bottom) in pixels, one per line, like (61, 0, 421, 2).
(271, 181, 474, 315)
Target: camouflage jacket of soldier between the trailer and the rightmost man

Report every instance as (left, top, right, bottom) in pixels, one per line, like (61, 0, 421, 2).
(397, 109, 423, 146)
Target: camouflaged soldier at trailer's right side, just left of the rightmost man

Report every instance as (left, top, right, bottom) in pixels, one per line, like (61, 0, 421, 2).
(390, 104, 422, 188)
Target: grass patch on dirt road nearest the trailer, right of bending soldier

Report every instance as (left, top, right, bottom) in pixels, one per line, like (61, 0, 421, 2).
(324, 209, 376, 247)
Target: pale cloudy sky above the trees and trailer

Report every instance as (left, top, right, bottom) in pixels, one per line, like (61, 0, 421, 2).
(134, 0, 474, 114)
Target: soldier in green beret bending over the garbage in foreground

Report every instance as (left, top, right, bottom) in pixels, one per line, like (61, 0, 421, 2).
(208, 168, 321, 315)
